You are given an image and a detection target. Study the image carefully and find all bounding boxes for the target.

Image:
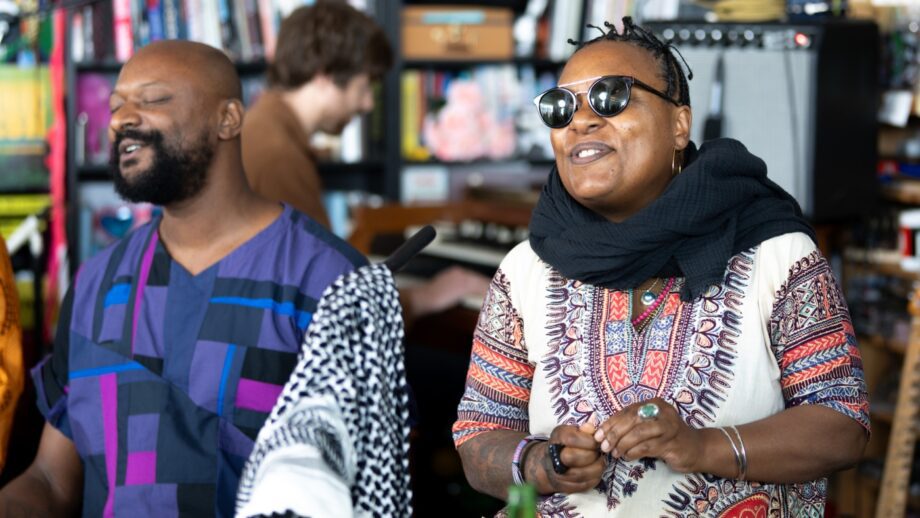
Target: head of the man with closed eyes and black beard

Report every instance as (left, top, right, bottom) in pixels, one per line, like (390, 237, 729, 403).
(109, 40, 243, 206)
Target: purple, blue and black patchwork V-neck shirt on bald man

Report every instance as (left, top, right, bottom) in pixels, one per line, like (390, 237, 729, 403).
(32, 206, 366, 518)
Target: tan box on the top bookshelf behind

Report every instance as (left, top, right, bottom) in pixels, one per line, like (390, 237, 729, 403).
(402, 5, 514, 60)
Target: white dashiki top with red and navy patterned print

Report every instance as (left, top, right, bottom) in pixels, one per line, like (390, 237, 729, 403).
(454, 233, 869, 518)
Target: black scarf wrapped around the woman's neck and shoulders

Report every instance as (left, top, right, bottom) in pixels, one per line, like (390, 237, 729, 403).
(530, 139, 815, 300)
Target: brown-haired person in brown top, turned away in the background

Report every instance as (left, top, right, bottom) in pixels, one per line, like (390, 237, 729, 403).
(243, 0, 489, 323)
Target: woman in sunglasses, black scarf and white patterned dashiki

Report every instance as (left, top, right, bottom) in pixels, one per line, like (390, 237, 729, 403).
(454, 18, 869, 517)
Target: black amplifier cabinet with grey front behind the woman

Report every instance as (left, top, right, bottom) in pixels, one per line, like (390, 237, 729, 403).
(645, 20, 880, 223)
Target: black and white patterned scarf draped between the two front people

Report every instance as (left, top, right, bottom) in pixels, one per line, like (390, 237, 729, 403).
(236, 265, 412, 517)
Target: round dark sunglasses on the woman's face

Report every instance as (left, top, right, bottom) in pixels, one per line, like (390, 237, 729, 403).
(533, 76, 680, 128)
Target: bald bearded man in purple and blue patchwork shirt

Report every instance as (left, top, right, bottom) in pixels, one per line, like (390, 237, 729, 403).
(0, 41, 364, 517)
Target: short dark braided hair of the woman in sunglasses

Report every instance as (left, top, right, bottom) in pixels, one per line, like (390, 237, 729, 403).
(569, 16, 693, 106)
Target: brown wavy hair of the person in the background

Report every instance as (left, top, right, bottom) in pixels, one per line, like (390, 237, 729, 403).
(268, 0, 393, 89)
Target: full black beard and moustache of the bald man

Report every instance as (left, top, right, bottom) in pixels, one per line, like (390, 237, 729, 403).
(109, 129, 214, 206)
